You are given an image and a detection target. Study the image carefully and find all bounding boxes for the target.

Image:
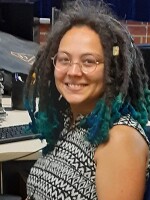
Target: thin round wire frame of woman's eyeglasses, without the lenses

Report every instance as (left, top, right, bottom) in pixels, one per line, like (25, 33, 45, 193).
(51, 52, 104, 74)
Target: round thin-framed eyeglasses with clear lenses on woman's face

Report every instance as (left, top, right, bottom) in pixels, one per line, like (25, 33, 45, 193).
(51, 52, 101, 74)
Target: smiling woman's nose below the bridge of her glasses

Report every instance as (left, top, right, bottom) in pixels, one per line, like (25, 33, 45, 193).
(67, 63, 82, 76)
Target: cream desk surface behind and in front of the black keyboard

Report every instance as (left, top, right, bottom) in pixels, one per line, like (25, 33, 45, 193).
(0, 98, 46, 161)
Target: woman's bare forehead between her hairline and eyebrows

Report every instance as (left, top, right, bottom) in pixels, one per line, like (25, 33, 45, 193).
(58, 26, 103, 54)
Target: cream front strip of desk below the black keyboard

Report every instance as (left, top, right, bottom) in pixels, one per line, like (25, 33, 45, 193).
(0, 139, 47, 161)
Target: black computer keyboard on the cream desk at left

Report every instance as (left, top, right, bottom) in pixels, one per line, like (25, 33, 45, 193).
(0, 124, 41, 144)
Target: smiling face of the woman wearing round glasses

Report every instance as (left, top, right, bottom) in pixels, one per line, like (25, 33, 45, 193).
(54, 26, 104, 114)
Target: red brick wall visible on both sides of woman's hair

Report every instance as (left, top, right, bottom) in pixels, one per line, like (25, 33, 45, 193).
(39, 21, 150, 44)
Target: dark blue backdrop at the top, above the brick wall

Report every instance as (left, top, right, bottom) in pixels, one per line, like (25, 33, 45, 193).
(39, 0, 150, 21)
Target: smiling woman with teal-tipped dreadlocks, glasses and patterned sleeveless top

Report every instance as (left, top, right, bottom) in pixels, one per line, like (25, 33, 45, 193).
(26, 1, 150, 200)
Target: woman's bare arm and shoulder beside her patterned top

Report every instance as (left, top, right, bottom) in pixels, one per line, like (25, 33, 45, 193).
(95, 125, 148, 200)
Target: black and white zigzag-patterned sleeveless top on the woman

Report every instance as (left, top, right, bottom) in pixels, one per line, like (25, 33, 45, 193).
(27, 115, 150, 200)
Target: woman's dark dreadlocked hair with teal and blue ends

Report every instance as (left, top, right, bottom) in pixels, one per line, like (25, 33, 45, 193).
(25, 0, 150, 153)
